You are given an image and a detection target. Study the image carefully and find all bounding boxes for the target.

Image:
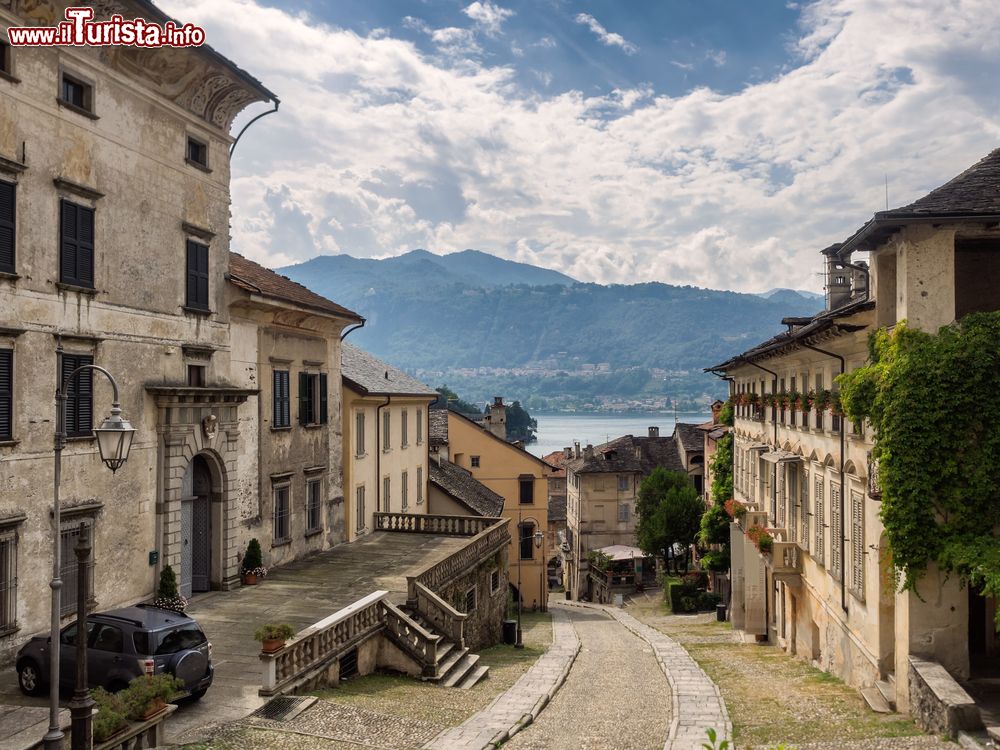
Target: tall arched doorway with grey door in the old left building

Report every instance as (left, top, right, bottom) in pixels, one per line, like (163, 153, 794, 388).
(180, 455, 214, 597)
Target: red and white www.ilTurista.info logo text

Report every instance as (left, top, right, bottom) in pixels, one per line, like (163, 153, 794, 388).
(7, 8, 205, 47)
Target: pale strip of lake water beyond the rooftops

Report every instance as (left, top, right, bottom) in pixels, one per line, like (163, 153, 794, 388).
(527, 412, 712, 456)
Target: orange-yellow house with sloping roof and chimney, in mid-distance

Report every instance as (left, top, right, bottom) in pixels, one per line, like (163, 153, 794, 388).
(431, 408, 555, 608)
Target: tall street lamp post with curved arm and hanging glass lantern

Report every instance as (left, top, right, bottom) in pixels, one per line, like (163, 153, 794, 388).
(42, 342, 135, 750)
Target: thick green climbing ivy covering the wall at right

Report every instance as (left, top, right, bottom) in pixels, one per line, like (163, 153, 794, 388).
(837, 313, 1000, 612)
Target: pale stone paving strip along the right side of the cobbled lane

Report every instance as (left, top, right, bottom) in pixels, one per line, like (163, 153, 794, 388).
(605, 607, 733, 750)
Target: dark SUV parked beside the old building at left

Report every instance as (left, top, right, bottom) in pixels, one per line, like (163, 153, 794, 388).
(16, 604, 214, 700)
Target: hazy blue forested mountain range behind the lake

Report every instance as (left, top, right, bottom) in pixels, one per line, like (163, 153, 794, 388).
(278, 250, 822, 408)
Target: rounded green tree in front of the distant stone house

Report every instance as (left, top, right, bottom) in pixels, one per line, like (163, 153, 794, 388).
(635, 466, 705, 561)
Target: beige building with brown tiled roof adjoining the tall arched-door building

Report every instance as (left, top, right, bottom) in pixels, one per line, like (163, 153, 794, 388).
(227, 253, 362, 580)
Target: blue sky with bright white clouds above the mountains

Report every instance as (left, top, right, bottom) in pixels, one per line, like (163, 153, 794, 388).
(160, 0, 1000, 291)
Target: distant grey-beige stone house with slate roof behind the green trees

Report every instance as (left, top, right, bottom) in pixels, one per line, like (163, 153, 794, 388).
(563, 423, 704, 599)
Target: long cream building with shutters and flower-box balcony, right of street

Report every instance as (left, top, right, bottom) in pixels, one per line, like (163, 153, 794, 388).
(712, 151, 1000, 731)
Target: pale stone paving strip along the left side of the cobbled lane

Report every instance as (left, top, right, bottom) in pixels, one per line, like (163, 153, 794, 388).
(424, 605, 580, 750)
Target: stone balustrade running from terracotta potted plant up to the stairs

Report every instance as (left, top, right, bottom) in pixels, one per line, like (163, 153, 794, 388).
(260, 591, 388, 695)
